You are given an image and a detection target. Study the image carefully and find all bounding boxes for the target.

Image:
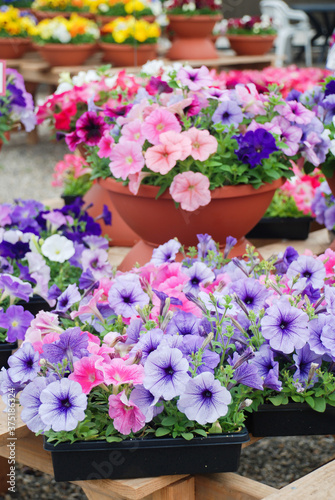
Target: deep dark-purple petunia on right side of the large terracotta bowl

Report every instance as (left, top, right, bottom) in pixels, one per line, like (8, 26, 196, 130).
(233, 128, 278, 168)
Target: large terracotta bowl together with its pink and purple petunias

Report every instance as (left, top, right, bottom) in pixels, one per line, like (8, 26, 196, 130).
(72, 66, 330, 270)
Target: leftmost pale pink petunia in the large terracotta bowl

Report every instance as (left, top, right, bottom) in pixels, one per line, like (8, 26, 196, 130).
(109, 141, 144, 181)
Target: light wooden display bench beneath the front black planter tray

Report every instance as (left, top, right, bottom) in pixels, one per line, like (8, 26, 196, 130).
(0, 402, 335, 500)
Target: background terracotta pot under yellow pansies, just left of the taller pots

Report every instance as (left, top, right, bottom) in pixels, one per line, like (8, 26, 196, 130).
(99, 42, 157, 67)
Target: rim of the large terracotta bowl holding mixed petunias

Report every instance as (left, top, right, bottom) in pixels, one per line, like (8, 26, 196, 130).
(97, 177, 285, 200)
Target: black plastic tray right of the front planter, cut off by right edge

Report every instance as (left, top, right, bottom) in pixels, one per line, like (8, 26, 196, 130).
(245, 403, 335, 437)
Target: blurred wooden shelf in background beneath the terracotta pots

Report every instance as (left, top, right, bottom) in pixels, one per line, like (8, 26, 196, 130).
(7, 51, 275, 85)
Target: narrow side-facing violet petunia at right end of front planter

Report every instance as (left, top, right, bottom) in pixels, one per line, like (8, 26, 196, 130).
(251, 344, 282, 391)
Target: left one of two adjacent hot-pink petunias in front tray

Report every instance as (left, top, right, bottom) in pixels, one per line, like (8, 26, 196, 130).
(68, 354, 104, 394)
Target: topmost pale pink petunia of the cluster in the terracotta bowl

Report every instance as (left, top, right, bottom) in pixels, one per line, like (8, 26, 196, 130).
(142, 108, 181, 145)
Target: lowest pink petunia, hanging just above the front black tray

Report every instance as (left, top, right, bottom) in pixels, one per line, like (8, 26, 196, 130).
(108, 391, 145, 435)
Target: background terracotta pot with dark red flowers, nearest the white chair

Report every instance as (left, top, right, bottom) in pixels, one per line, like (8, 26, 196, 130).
(226, 35, 276, 56)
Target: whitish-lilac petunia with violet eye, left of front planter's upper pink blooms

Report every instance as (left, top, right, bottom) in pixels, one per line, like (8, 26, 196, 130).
(108, 274, 149, 318)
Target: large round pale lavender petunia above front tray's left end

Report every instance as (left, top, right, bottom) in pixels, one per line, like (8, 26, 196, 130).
(39, 378, 87, 432)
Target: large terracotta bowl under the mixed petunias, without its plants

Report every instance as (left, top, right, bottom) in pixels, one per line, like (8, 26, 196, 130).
(98, 178, 283, 271)
